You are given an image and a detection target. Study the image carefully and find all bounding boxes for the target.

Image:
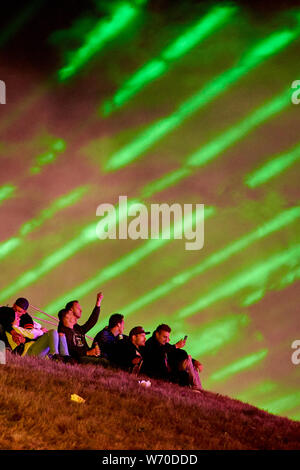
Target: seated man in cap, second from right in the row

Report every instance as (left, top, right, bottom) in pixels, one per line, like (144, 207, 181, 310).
(113, 326, 150, 374)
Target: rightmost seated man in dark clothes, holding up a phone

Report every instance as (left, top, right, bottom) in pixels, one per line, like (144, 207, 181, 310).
(141, 324, 202, 390)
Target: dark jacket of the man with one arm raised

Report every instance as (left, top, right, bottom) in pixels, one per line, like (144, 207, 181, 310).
(57, 307, 100, 360)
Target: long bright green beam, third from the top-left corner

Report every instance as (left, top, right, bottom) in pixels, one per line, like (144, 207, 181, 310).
(104, 25, 300, 171)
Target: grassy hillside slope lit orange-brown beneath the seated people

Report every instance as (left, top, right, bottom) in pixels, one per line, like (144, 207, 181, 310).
(0, 354, 300, 450)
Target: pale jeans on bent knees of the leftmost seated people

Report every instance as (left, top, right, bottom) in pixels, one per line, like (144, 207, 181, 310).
(27, 330, 69, 357)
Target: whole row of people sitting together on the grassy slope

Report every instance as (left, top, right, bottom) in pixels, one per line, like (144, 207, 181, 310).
(0, 292, 202, 391)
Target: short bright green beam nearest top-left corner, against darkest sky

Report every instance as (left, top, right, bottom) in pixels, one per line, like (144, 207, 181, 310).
(58, 2, 139, 81)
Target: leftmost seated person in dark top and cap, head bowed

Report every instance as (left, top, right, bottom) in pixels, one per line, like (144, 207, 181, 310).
(0, 297, 34, 349)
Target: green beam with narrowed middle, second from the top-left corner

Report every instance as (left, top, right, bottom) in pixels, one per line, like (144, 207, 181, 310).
(101, 5, 237, 116)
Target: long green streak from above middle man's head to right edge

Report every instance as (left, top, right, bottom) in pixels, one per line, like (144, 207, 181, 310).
(122, 207, 300, 316)
